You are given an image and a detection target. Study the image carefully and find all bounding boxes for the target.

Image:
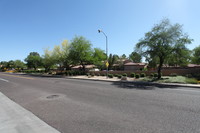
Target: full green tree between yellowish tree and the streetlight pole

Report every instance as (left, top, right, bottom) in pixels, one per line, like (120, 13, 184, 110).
(69, 36, 93, 71)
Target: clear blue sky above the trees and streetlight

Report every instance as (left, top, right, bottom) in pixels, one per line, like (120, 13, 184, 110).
(0, 0, 200, 61)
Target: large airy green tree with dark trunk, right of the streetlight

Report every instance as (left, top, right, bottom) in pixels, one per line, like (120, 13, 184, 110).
(136, 19, 192, 79)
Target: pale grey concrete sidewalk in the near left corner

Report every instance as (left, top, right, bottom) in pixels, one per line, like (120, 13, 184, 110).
(0, 92, 60, 133)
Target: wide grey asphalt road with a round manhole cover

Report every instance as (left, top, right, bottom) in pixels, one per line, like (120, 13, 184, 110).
(0, 73, 200, 133)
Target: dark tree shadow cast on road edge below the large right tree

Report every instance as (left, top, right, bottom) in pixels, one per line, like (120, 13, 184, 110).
(113, 82, 180, 90)
